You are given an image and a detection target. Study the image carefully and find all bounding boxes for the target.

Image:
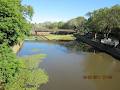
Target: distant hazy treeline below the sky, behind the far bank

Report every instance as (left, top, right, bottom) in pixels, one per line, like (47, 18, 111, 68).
(32, 17, 86, 30)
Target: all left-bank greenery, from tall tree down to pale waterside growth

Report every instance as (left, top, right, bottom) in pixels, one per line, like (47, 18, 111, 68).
(0, 0, 48, 90)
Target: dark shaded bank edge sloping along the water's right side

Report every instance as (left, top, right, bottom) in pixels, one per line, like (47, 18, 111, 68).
(77, 35, 120, 60)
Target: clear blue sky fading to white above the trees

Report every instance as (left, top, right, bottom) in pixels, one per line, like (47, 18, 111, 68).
(22, 0, 120, 23)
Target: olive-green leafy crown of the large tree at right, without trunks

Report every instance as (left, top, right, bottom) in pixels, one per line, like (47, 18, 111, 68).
(87, 5, 120, 37)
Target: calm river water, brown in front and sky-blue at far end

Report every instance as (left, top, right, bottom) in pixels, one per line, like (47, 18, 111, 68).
(18, 41, 120, 90)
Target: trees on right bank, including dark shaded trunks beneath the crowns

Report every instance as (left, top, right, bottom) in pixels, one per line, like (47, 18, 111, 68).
(76, 5, 120, 40)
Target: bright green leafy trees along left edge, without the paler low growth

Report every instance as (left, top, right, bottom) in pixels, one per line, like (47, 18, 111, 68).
(0, 0, 33, 90)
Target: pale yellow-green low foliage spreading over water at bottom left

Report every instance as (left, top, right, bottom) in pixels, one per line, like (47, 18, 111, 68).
(6, 54, 48, 90)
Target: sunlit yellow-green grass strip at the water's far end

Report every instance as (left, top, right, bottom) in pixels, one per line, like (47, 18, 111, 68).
(26, 34, 75, 41)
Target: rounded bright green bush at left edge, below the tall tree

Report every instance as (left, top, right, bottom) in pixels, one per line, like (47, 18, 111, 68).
(0, 44, 20, 89)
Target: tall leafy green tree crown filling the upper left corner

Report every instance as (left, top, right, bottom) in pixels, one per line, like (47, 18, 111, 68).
(0, 0, 33, 45)
